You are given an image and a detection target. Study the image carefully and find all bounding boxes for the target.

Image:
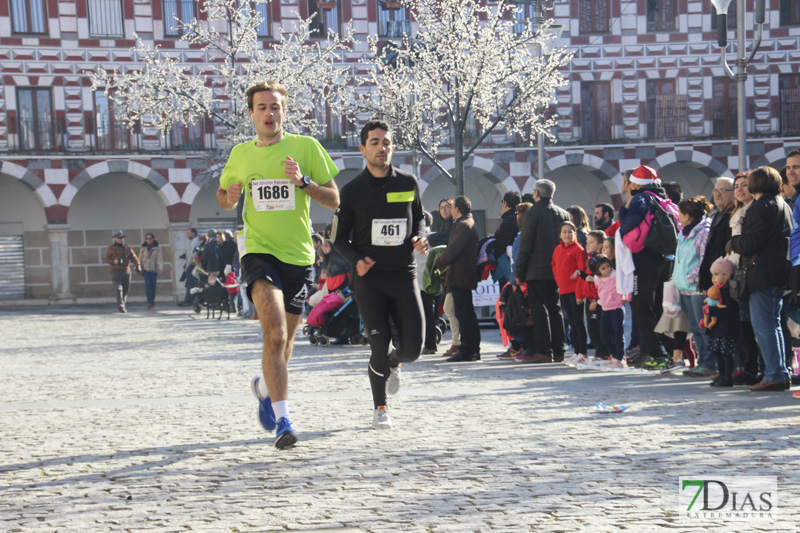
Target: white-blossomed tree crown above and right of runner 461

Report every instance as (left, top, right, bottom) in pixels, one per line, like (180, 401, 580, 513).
(357, 0, 571, 194)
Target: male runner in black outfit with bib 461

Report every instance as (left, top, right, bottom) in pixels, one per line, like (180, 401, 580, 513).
(331, 121, 428, 429)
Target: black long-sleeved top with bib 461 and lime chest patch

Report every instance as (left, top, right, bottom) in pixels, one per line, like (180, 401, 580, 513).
(331, 166, 425, 279)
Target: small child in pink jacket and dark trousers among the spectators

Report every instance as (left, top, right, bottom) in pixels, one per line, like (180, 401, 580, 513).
(594, 254, 627, 368)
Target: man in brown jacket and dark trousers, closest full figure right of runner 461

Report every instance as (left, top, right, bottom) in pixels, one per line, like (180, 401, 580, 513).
(436, 196, 481, 362)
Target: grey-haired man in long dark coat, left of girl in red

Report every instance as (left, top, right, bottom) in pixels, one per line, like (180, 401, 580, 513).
(514, 179, 569, 363)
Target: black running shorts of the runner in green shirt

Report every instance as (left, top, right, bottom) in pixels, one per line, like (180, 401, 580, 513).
(241, 254, 314, 315)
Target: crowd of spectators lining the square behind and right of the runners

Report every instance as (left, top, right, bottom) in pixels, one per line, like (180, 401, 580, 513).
(169, 149, 800, 391)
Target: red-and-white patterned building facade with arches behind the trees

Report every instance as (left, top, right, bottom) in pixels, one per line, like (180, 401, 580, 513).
(0, 0, 800, 301)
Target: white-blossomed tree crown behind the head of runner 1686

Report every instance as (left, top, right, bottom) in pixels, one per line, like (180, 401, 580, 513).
(88, 0, 354, 181)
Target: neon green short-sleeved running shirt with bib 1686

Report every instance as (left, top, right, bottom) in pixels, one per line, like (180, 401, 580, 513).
(219, 133, 339, 266)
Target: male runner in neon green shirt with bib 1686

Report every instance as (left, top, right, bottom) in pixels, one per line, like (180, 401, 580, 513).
(217, 81, 339, 449)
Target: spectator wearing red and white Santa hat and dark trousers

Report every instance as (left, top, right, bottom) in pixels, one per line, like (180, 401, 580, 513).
(618, 165, 672, 365)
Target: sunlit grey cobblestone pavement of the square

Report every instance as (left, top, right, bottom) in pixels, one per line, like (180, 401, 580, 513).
(0, 306, 800, 533)
